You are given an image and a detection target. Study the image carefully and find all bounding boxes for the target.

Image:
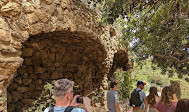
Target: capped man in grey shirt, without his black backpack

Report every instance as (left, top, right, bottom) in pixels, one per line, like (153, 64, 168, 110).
(133, 81, 146, 112)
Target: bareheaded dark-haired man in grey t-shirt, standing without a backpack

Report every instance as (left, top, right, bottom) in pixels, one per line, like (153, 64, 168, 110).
(107, 81, 120, 112)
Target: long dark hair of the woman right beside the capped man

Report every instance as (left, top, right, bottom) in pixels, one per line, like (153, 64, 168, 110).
(146, 87, 158, 106)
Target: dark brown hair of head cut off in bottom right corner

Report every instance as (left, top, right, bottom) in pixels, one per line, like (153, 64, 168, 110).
(175, 99, 189, 112)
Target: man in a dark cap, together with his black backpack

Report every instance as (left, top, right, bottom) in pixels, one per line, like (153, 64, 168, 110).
(129, 81, 146, 112)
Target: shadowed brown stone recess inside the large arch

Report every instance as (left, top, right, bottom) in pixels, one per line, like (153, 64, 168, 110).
(7, 31, 107, 112)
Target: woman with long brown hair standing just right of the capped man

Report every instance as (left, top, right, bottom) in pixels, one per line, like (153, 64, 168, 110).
(144, 87, 159, 112)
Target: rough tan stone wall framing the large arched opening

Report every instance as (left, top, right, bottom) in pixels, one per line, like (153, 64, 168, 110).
(0, 0, 128, 112)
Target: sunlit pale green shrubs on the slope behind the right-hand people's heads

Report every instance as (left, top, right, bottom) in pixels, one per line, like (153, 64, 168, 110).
(133, 59, 189, 89)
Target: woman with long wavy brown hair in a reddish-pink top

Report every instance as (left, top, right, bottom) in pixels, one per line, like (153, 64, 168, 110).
(156, 86, 178, 112)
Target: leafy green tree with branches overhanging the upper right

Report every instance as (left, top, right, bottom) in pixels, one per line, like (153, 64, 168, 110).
(82, 0, 189, 77)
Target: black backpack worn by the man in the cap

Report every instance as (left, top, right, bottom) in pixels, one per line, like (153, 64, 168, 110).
(129, 89, 142, 107)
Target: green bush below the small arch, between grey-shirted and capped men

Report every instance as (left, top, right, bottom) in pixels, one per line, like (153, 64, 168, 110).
(116, 71, 132, 100)
